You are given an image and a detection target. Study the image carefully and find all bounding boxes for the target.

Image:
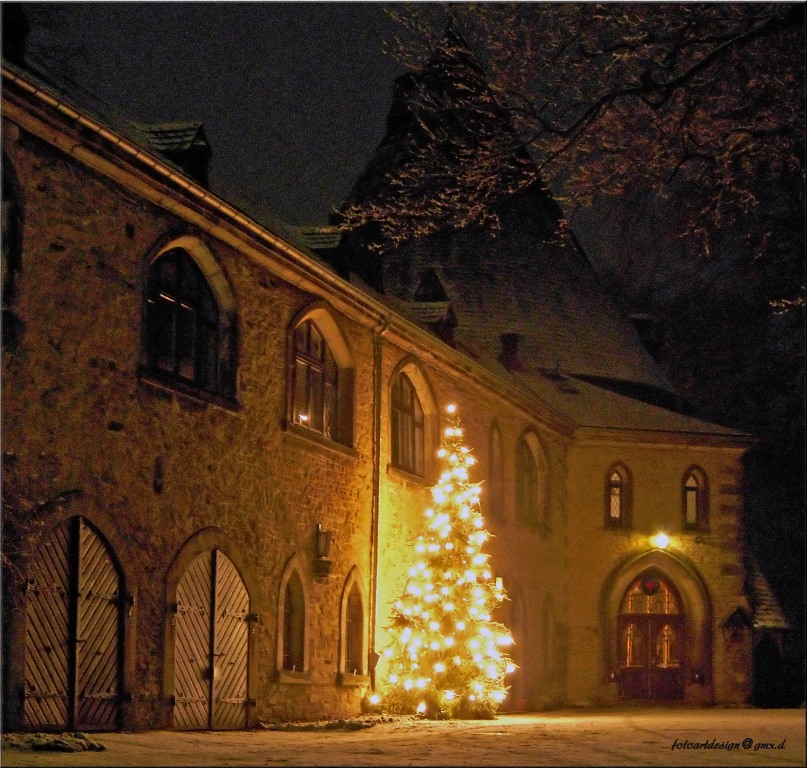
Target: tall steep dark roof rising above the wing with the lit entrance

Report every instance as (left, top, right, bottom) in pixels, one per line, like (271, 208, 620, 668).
(342, 28, 742, 436)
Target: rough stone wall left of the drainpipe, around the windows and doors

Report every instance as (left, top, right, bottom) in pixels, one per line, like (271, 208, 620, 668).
(3, 118, 373, 727)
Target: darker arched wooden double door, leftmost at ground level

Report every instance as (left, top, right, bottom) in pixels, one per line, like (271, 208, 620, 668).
(23, 517, 129, 730)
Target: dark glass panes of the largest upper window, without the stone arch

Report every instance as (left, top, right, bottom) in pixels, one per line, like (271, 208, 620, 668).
(146, 248, 234, 397)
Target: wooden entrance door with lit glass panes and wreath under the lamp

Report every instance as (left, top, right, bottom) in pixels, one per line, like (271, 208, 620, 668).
(617, 569, 686, 700)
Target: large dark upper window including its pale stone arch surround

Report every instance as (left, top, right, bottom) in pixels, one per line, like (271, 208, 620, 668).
(144, 235, 236, 400)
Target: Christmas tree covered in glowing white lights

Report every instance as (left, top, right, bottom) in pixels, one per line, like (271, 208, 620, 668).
(384, 406, 515, 719)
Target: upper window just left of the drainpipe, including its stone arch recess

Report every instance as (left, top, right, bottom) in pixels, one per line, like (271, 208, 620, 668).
(287, 302, 354, 446)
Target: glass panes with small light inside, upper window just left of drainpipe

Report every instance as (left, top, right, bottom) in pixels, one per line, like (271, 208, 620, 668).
(292, 320, 339, 440)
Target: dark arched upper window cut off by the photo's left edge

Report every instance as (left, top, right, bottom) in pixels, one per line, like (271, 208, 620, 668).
(0, 154, 24, 345)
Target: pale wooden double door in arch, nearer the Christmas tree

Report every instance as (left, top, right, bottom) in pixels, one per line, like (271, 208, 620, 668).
(173, 549, 251, 730)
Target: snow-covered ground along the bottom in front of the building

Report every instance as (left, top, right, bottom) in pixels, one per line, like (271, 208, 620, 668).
(2, 708, 805, 767)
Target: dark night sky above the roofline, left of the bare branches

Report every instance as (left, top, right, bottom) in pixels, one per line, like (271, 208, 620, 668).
(28, 2, 402, 224)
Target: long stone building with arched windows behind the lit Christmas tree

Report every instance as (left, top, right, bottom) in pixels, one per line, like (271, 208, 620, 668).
(2, 54, 784, 730)
